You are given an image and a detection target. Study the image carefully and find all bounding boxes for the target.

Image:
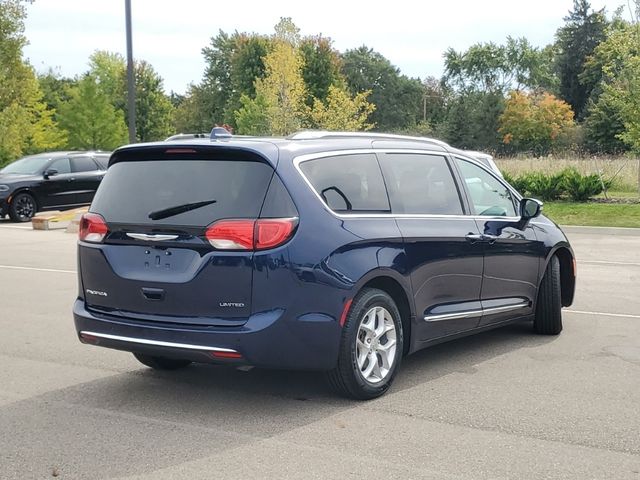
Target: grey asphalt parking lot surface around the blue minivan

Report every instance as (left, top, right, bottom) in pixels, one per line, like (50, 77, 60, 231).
(0, 221, 640, 480)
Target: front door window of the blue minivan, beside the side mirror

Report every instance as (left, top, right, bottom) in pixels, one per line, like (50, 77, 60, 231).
(456, 158, 517, 217)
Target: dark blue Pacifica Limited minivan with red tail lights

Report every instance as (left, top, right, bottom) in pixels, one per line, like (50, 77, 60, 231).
(73, 132, 575, 399)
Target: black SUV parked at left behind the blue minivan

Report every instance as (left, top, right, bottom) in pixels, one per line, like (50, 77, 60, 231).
(0, 152, 109, 222)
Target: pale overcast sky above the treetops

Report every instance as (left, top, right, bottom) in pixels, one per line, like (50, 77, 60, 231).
(25, 0, 626, 93)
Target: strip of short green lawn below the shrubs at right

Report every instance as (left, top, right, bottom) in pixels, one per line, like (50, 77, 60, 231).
(544, 202, 640, 228)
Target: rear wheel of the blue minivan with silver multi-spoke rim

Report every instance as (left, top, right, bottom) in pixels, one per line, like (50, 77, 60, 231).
(327, 288, 403, 400)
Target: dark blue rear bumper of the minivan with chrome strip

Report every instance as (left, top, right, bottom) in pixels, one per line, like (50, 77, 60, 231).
(73, 299, 341, 370)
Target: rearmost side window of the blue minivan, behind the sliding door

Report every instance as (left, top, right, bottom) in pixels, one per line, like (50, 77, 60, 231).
(300, 153, 391, 213)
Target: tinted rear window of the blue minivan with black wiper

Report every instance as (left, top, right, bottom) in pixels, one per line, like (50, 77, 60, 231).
(90, 160, 273, 227)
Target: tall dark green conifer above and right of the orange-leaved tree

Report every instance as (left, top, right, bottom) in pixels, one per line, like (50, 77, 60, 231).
(555, 0, 609, 120)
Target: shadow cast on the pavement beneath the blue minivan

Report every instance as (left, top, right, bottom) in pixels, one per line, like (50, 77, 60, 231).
(0, 325, 553, 479)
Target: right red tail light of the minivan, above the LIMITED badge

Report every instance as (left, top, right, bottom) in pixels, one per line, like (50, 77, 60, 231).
(205, 218, 298, 250)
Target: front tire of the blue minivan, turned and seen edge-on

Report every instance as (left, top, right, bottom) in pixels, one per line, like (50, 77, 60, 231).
(533, 255, 562, 335)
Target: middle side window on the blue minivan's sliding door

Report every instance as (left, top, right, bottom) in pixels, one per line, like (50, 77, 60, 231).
(379, 153, 463, 215)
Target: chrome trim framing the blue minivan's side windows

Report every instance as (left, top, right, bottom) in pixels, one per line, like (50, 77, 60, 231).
(293, 148, 522, 222)
